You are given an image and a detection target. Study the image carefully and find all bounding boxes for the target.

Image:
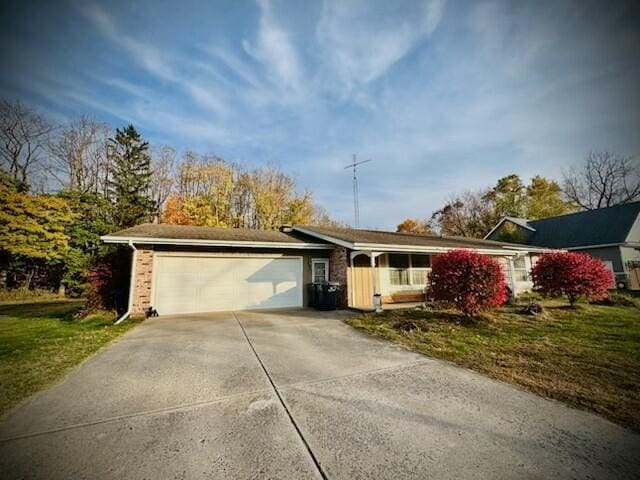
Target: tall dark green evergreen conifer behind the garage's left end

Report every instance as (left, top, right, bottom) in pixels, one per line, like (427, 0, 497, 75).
(108, 125, 156, 228)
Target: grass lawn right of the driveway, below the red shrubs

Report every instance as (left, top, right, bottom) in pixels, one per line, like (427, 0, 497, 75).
(348, 301, 640, 430)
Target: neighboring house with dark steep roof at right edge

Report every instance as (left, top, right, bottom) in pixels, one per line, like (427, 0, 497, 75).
(485, 202, 640, 290)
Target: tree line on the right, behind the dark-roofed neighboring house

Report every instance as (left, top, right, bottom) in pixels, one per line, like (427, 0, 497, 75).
(397, 151, 640, 238)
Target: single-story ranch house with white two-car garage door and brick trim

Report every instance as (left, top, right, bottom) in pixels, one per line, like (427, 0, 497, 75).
(102, 224, 546, 315)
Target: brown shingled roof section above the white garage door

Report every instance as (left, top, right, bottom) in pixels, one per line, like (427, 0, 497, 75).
(107, 223, 324, 243)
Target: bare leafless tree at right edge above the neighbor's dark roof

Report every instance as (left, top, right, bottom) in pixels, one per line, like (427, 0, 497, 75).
(563, 152, 640, 210)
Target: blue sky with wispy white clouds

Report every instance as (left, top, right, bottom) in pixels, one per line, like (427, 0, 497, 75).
(0, 0, 640, 228)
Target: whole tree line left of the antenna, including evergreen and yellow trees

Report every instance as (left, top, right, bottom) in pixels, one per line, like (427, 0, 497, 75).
(0, 101, 336, 295)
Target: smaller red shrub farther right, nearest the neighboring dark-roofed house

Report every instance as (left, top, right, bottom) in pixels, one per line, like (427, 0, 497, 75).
(531, 252, 614, 306)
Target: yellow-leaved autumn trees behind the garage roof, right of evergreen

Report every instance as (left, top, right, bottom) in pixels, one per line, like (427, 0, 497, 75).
(156, 152, 337, 230)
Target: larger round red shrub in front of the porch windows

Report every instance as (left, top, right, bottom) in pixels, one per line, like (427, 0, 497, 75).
(429, 250, 507, 315)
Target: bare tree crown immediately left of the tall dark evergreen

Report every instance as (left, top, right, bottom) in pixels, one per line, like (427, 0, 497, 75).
(49, 116, 109, 193)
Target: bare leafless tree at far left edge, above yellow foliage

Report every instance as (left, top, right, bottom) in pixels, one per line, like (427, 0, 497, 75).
(0, 100, 53, 189)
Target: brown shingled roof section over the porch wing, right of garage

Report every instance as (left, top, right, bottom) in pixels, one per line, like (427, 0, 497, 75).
(300, 226, 522, 248)
